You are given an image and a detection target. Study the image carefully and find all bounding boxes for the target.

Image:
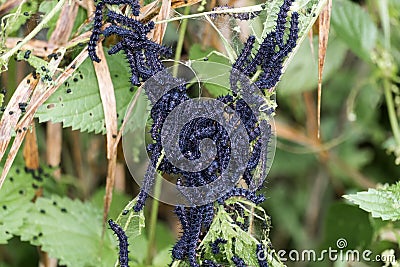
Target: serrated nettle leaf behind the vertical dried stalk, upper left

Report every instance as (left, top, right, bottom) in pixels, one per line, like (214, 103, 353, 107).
(36, 49, 136, 134)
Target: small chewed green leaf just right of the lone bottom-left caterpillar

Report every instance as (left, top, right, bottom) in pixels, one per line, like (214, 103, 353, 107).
(116, 197, 147, 264)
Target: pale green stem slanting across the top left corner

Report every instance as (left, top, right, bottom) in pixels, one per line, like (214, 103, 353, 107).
(0, 0, 65, 72)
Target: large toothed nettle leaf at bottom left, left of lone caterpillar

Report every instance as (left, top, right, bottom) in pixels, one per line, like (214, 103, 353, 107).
(20, 196, 117, 267)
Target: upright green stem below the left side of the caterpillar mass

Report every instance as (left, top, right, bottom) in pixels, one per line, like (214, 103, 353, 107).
(146, 153, 164, 265)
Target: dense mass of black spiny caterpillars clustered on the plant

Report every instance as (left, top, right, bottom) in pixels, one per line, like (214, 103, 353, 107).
(88, 0, 298, 267)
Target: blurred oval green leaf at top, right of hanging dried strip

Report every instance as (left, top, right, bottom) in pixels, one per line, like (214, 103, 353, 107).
(327, 0, 378, 62)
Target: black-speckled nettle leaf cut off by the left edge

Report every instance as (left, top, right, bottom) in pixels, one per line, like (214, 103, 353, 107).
(0, 167, 42, 244)
